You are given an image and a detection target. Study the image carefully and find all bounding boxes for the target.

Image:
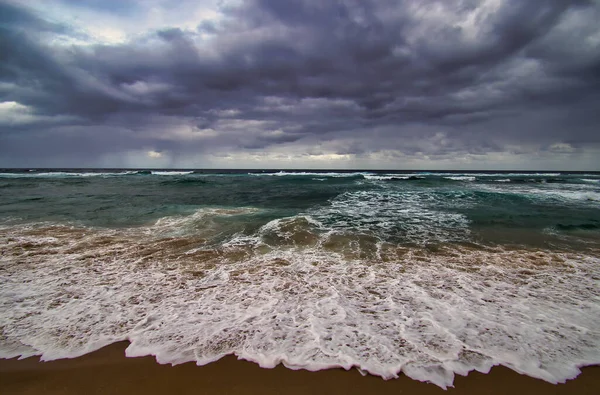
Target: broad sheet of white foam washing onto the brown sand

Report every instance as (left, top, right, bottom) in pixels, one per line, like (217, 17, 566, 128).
(0, 226, 600, 388)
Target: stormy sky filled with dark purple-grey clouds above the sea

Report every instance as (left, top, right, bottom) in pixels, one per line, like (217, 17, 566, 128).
(0, 0, 600, 170)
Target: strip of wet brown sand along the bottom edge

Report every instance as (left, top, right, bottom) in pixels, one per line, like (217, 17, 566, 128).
(0, 342, 600, 395)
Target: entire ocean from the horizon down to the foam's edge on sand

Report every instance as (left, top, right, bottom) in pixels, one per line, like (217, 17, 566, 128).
(0, 169, 600, 388)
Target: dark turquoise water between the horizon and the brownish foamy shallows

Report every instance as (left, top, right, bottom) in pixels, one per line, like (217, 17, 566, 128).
(0, 170, 600, 248)
